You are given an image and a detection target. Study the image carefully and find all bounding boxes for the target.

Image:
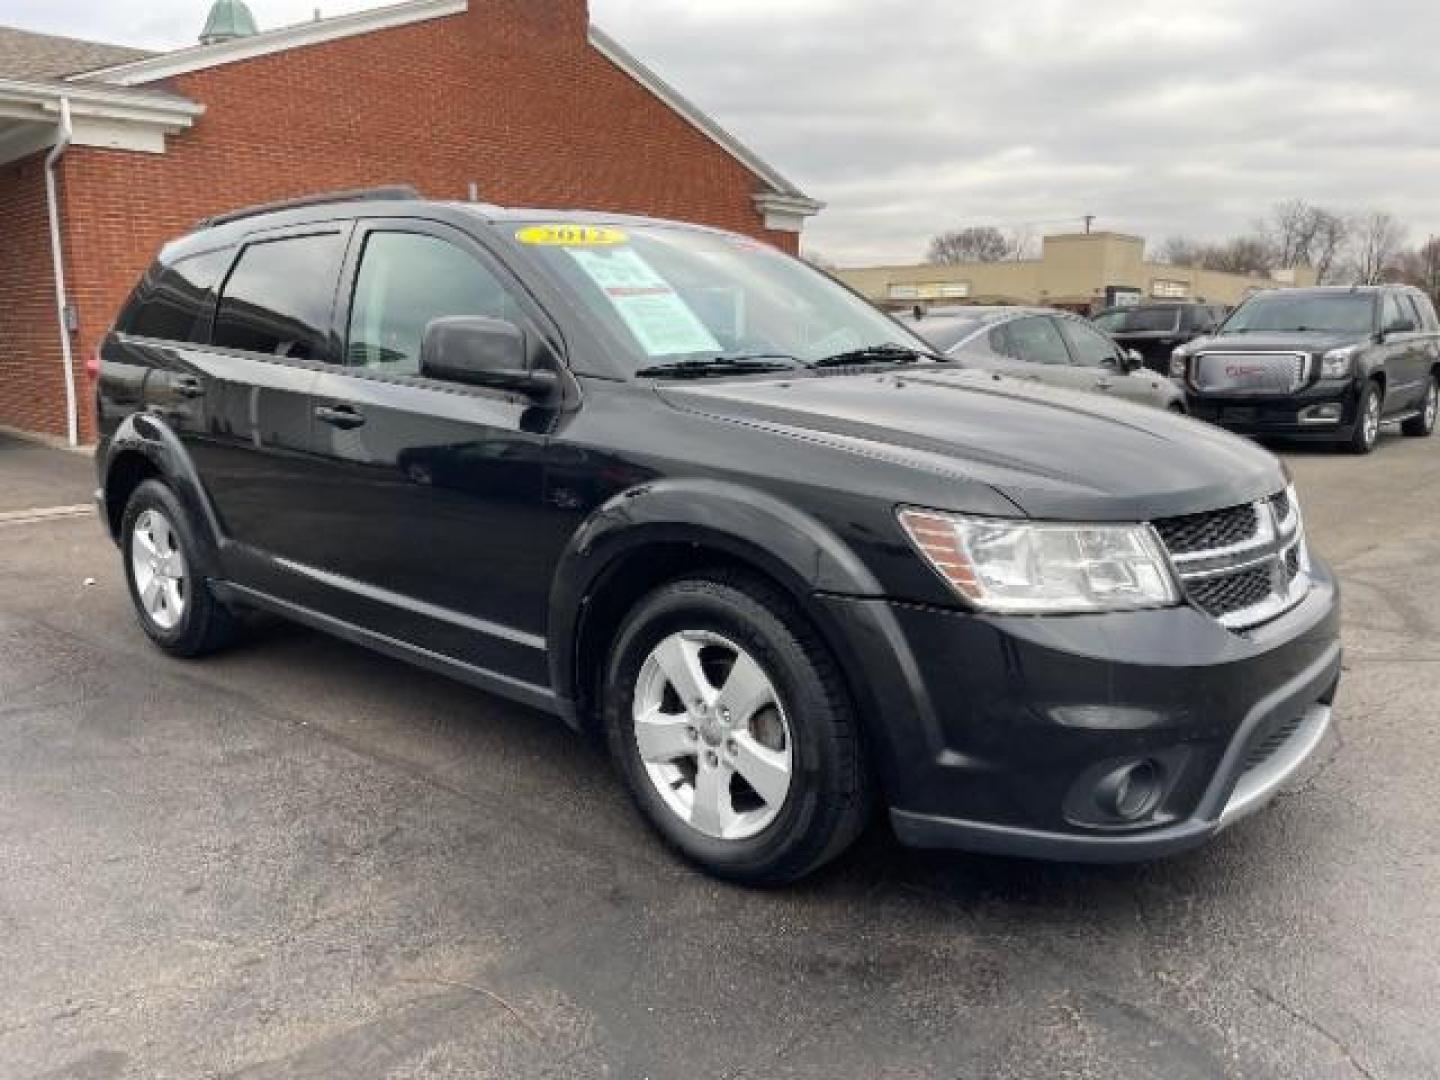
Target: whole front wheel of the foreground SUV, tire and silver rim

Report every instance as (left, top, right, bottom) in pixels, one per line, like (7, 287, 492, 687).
(605, 573, 870, 884)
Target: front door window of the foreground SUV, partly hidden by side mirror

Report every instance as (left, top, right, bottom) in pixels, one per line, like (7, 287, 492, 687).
(346, 232, 521, 374)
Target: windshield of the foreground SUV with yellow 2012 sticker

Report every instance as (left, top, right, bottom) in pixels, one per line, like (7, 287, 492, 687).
(514, 222, 932, 374)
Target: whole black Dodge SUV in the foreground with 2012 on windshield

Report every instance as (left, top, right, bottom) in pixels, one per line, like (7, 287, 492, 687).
(98, 194, 1341, 881)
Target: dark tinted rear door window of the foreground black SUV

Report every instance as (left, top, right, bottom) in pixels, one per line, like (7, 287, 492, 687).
(210, 233, 344, 360)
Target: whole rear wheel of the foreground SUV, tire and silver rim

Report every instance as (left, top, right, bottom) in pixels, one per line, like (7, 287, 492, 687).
(121, 480, 236, 657)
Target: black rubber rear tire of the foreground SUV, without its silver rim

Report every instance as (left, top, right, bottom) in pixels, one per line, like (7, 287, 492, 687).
(120, 480, 239, 658)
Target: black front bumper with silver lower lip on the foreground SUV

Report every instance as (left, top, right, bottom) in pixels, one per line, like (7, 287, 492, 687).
(827, 562, 1341, 861)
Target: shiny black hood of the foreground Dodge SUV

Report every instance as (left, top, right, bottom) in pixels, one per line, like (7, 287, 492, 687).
(658, 369, 1286, 521)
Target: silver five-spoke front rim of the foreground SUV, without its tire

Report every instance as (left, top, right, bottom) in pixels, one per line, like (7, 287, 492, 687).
(632, 631, 793, 840)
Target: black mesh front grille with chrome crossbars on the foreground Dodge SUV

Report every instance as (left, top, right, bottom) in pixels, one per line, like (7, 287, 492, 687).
(1151, 491, 1308, 629)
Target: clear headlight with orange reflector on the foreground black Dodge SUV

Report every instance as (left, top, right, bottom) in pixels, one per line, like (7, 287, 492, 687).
(900, 510, 1179, 615)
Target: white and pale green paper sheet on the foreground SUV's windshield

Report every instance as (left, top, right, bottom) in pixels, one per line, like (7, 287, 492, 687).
(569, 248, 721, 357)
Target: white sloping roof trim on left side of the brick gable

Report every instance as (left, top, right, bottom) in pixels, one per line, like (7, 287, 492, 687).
(71, 0, 469, 86)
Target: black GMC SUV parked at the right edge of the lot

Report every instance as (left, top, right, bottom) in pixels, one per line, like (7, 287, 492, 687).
(1171, 285, 1440, 454)
